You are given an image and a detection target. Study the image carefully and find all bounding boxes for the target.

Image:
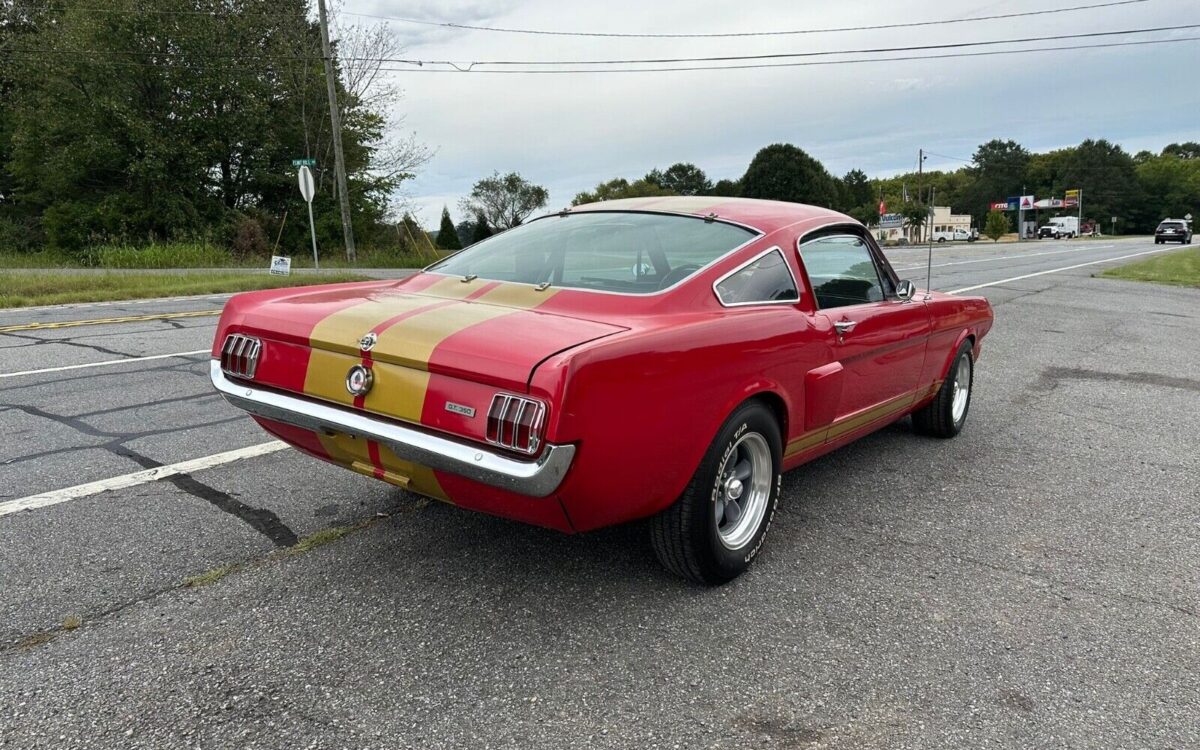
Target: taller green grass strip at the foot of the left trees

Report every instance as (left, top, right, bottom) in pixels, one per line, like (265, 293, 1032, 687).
(0, 242, 443, 270)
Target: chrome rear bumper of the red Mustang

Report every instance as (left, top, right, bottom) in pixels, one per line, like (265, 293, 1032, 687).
(209, 360, 575, 497)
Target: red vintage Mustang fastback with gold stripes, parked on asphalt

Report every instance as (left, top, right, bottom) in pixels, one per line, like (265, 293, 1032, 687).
(211, 197, 992, 583)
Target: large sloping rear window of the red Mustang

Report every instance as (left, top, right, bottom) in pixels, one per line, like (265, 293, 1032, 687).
(430, 211, 757, 294)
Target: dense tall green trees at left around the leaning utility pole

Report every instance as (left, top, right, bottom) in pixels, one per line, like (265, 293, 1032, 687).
(0, 0, 428, 248)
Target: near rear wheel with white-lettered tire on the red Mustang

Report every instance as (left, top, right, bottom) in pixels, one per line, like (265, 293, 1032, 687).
(650, 401, 784, 586)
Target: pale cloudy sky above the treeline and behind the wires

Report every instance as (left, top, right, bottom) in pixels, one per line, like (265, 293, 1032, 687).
(340, 0, 1200, 227)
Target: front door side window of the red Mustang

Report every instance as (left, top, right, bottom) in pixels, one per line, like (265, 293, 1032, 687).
(799, 234, 886, 310)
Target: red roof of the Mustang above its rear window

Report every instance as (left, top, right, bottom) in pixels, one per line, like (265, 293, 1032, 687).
(571, 196, 858, 233)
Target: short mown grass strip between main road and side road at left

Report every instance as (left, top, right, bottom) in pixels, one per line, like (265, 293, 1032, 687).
(0, 271, 368, 307)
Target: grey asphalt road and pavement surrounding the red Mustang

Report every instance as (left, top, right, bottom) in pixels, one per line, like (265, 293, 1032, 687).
(0, 240, 1200, 750)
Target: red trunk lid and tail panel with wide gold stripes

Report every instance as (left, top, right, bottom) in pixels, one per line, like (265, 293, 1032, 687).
(236, 277, 628, 440)
